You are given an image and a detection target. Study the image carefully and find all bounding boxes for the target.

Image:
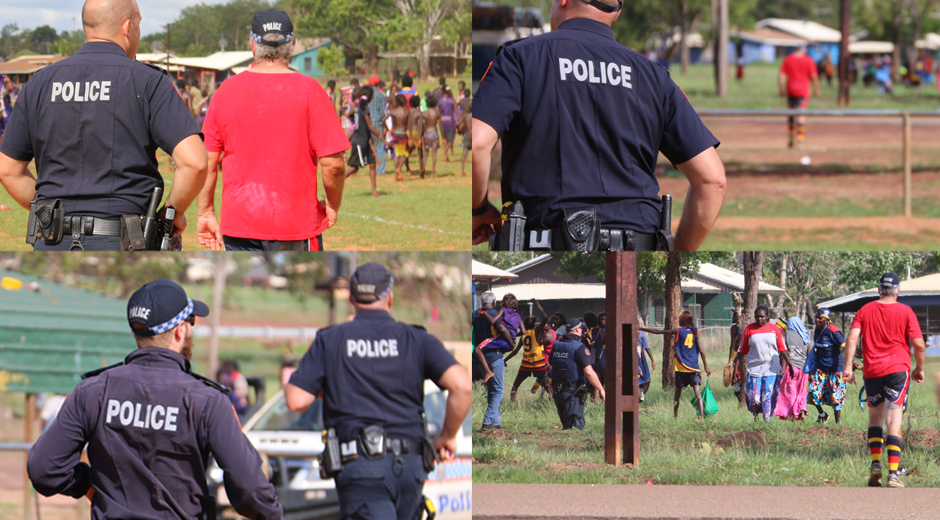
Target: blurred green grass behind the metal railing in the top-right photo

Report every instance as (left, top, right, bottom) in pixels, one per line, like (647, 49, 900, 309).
(669, 62, 940, 110)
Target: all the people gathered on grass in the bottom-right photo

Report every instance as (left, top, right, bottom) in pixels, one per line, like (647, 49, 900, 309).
(472, 273, 928, 487)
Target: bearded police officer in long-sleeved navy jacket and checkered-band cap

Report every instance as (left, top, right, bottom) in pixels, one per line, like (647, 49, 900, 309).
(27, 279, 283, 519)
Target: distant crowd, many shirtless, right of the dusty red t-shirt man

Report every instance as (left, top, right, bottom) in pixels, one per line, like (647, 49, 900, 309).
(326, 71, 473, 185)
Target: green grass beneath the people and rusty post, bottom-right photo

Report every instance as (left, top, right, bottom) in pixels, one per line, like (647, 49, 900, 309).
(473, 352, 940, 487)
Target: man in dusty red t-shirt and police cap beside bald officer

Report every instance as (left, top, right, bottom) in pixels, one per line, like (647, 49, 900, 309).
(196, 9, 350, 251)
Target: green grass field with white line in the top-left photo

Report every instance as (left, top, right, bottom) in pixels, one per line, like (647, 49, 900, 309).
(0, 77, 471, 251)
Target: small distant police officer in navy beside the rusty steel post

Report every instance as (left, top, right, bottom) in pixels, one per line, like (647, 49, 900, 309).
(552, 318, 607, 430)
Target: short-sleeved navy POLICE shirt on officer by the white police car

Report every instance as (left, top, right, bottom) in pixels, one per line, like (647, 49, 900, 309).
(290, 309, 457, 442)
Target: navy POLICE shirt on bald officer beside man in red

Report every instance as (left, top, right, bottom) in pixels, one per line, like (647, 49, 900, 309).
(0, 42, 199, 218)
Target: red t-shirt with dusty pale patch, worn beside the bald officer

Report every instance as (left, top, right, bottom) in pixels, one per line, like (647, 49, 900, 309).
(203, 71, 349, 240)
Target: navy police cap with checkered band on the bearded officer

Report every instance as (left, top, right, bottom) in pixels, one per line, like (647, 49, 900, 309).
(127, 278, 209, 336)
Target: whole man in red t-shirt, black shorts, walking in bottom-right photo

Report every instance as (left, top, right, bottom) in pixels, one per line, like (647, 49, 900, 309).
(842, 273, 926, 487)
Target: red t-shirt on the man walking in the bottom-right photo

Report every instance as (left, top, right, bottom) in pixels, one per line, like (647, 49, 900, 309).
(852, 302, 923, 378)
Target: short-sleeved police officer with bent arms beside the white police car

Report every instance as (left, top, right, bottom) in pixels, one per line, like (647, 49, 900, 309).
(284, 263, 471, 520)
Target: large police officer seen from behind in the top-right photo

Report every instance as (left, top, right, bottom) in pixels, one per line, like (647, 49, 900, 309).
(473, 0, 725, 250)
